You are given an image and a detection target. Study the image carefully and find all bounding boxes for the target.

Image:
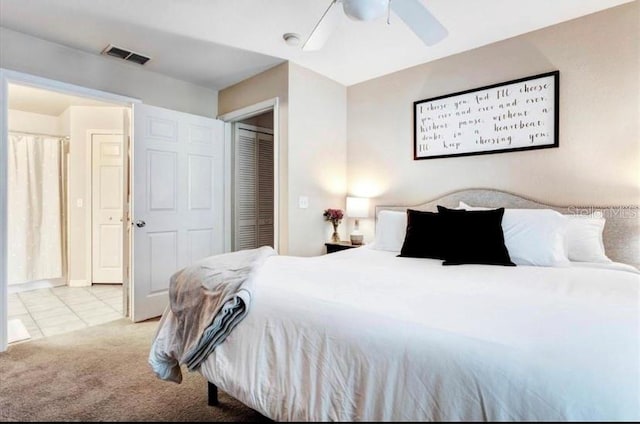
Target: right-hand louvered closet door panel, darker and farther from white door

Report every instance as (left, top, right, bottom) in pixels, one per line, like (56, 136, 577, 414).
(257, 133, 273, 247)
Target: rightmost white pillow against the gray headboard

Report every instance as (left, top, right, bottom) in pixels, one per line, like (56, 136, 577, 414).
(566, 214, 612, 263)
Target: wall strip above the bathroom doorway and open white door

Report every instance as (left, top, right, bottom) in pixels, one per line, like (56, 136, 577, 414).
(0, 28, 218, 117)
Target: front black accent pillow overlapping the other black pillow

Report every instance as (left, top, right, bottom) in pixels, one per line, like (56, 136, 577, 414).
(438, 205, 515, 266)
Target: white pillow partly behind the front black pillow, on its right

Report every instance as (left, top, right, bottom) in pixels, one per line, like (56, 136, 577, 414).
(458, 202, 569, 267)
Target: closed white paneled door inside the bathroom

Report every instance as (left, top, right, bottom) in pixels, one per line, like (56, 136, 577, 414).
(91, 134, 124, 284)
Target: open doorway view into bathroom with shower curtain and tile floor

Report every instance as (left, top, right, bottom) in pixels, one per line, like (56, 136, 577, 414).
(6, 83, 128, 343)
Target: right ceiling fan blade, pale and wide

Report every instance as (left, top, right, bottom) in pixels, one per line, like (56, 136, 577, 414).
(391, 0, 449, 46)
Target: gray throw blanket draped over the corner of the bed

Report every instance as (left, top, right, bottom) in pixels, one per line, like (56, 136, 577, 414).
(149, 246, 276, 383)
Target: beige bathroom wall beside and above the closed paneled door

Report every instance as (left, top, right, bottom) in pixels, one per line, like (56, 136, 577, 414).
(67, 106, 125, 286)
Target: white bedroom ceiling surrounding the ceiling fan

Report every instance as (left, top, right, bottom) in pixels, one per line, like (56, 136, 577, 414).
(0, 0, 633, 89)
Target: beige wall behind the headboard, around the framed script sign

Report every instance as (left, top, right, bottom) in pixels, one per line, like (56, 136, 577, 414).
(347, 2, 640, 242)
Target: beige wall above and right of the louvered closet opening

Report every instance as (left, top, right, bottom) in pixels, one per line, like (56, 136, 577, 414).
(218, 63, 289, 254)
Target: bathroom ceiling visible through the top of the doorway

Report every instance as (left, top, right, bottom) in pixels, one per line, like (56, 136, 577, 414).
(8, 84, 115, 116)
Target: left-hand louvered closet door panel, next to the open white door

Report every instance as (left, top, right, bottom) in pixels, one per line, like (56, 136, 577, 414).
(235, 129, 258, 250)
